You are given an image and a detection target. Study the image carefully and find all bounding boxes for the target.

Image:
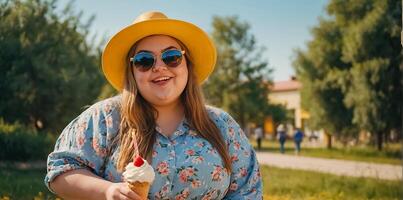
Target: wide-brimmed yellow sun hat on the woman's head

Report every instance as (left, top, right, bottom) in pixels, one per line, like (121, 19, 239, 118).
(102, 11, 217, 91)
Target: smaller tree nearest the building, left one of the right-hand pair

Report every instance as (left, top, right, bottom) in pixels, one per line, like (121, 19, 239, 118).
(293, 19, 357, 148)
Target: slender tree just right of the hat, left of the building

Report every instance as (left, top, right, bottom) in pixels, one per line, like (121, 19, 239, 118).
(203, 16, 282, 127)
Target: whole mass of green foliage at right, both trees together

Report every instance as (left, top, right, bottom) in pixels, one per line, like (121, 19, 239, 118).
(294, 0, 403, 149)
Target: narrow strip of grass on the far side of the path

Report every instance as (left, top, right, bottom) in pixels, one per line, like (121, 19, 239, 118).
(250, 139, 402, 165)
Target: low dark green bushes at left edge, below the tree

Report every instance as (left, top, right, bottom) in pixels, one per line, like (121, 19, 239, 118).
(0, 119, 55, 161)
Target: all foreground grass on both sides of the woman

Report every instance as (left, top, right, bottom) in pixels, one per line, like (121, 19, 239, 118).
(0, 166, 403, 200)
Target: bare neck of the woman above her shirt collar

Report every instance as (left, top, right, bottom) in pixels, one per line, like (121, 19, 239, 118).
(155, 101, 185, 137)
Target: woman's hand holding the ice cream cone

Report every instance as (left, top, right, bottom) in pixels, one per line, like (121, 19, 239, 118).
(105, 183, 143, 200)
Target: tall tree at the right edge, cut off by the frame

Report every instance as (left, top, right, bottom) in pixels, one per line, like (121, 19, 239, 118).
(328, 0, 402, 150)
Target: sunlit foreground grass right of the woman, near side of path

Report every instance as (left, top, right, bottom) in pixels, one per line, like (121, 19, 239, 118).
(261, 166, 403, 200)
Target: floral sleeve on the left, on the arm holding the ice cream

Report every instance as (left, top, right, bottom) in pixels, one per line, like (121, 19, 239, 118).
(44, 97, 120, 193)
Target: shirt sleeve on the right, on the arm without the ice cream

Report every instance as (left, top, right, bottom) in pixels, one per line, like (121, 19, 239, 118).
(221, 112, 263, 200)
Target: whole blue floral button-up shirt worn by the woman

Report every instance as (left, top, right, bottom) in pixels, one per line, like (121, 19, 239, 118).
(45, 96, 262, 200)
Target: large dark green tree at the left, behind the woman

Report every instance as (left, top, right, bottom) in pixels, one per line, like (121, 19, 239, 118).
(0, 0, 104, 131)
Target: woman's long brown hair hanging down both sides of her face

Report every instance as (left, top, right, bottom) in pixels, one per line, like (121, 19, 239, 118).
(117, 38, 231, 173)
